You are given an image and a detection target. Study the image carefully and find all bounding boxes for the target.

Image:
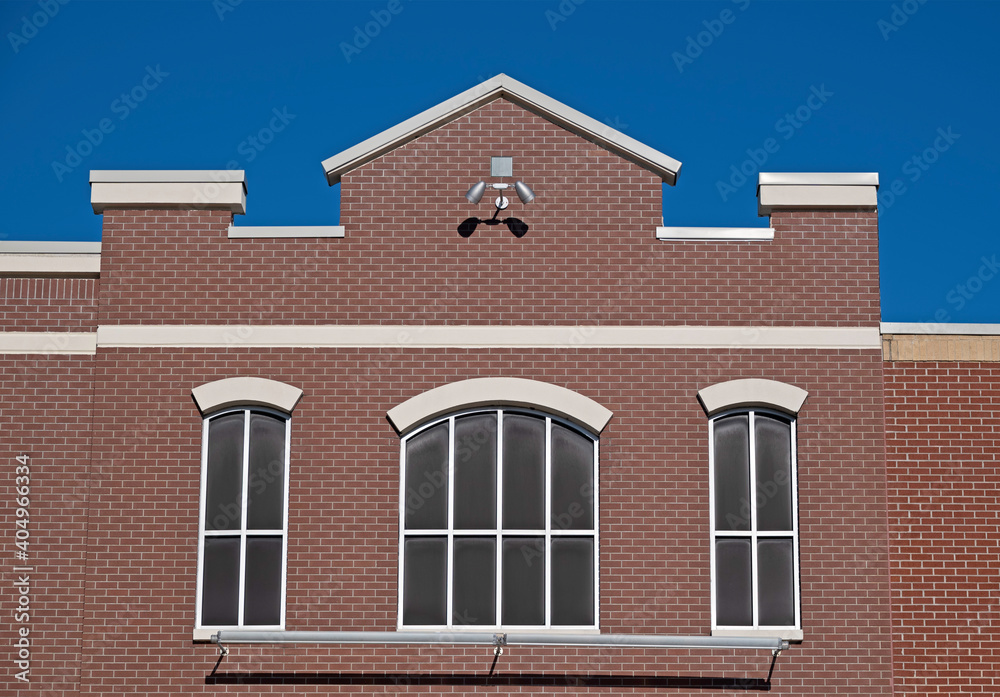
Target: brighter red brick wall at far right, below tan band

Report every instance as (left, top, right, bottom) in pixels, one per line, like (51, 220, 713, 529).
(886, 362, 1000, 695)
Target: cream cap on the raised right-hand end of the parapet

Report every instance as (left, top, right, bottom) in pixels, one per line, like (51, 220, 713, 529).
(757, 172, 878, 216)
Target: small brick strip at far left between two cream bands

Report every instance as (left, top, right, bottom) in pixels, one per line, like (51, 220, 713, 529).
(0, 278, 98, 332)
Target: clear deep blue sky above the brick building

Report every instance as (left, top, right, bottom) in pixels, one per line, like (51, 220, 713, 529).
(0, 0, 1000, 323)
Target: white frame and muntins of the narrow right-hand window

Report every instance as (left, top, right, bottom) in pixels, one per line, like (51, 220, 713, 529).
(708, 407, 802, 639)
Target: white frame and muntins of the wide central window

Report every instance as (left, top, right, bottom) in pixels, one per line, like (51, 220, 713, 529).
(396, 407, 601, 633)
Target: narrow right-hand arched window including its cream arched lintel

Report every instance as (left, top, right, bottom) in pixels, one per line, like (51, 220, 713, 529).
(698, 379, 807, 639)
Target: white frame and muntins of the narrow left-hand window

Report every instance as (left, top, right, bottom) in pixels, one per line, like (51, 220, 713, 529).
(195, 406, 292, 636)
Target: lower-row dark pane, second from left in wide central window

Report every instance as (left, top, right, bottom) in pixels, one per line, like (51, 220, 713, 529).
(451, 537, 497, 624)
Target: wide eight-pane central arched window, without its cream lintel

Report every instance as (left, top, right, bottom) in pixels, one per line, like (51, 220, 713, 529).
(399, 407, 610, 629)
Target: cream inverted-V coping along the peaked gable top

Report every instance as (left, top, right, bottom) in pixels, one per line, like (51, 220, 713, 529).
(323, 73, 681, 186)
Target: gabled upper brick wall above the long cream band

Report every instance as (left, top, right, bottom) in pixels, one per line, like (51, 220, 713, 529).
(94, 100, 879, 326)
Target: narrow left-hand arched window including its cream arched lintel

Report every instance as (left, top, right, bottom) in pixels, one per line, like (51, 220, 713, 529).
(193, 378, 302, 636)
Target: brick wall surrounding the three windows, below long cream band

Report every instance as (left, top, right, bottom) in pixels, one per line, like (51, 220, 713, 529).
(76, 347, 890, 695)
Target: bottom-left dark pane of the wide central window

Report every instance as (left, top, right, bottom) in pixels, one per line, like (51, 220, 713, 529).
(403, 537, 448, 624)
